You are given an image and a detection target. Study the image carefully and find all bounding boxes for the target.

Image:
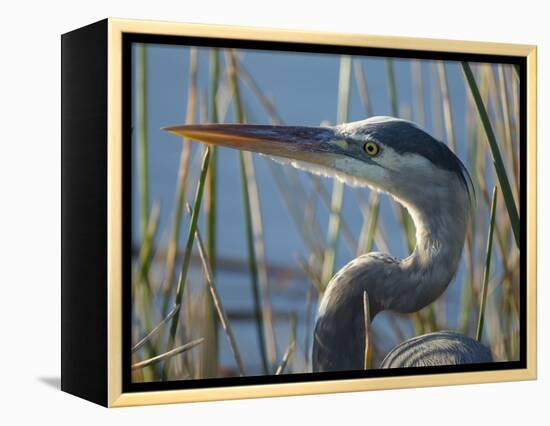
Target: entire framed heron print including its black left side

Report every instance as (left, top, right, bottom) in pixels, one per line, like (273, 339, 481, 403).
(61, 19, 536, 406)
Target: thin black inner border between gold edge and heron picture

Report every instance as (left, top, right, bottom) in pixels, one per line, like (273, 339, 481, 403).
(122, 33, 527, 392)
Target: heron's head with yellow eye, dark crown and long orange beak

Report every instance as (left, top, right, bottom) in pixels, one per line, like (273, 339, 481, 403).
(165, 117, 471, 203)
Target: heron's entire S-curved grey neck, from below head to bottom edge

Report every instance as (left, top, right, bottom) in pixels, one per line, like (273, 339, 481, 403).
(312, 181, 470, 371)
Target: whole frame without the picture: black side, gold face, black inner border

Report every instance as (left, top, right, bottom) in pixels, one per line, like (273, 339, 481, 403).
(61, 18, 537, 407)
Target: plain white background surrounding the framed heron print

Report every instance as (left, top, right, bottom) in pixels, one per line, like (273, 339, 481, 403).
(0, 0, 550, 426)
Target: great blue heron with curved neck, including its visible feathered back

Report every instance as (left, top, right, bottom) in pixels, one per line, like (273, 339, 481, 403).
(166, 117, 492, 371)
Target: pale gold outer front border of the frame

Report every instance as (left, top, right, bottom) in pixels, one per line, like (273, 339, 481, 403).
(107, 18, 537, 407)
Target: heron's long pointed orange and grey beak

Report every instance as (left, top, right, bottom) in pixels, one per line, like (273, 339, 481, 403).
(163, 124, 342, 165)
